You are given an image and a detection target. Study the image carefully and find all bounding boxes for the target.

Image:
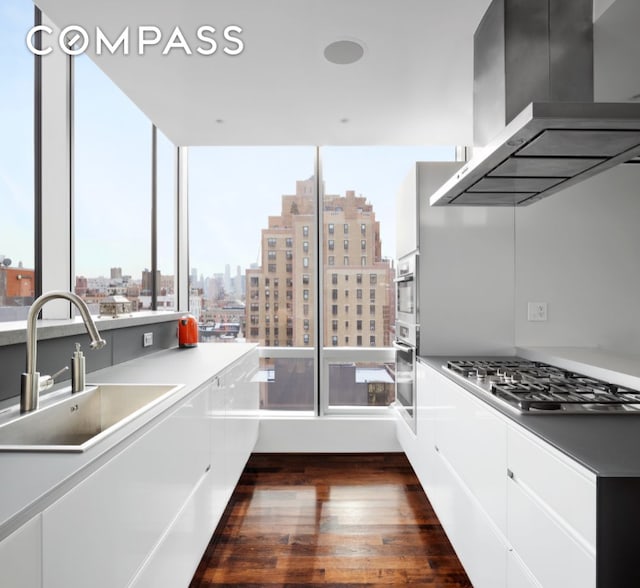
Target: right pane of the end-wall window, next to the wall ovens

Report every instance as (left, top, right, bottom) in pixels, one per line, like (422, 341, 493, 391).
(321, 146, 454, 412)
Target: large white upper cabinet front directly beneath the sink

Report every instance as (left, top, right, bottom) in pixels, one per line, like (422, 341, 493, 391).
(43, 386, 210, 588)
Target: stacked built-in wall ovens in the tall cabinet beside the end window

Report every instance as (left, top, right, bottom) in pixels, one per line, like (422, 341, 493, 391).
(393, 253, 420, 433)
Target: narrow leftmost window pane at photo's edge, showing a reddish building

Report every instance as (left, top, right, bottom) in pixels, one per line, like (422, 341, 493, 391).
(0, 0, 35, 321)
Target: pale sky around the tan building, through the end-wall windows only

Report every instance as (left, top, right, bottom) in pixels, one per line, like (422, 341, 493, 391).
(189, 146, 453, 276)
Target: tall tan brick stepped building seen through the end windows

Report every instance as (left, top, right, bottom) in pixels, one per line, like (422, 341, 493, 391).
(246, 178, 395, 347)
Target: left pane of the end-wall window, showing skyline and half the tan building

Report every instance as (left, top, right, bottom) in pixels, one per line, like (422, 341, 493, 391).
(189, 147, 318, 411)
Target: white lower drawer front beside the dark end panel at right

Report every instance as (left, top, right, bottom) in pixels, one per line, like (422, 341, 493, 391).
(507, 479, 596, 588)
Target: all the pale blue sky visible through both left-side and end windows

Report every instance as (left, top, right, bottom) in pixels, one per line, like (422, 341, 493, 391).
(0, 0, 453, 278)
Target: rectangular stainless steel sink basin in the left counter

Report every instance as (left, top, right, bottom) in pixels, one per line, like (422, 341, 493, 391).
(0, 384, 182, 452)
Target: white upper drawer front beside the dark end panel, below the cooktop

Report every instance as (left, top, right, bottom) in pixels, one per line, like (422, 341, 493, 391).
(507, 426, 596, 552)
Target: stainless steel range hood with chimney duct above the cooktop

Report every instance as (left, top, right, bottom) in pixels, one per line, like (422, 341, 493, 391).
(430, 0, 640, 206)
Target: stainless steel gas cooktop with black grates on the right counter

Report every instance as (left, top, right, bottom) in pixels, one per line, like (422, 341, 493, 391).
(443, 357, 640, 415)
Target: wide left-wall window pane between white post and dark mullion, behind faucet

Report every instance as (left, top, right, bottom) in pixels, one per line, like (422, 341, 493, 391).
(73, 55, 152, 313)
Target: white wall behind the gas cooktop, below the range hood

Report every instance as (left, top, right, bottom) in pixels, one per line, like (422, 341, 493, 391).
(515, 165, 640, 354)
